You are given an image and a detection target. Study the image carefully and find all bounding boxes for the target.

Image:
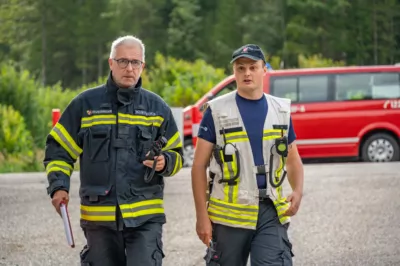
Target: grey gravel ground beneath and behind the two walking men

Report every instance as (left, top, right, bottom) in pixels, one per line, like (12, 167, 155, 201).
(0, 163, 400, 266)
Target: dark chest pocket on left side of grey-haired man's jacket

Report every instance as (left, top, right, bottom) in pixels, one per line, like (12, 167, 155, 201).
(88, 126, 111, 163)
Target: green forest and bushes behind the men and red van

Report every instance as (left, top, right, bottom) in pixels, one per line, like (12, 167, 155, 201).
(0, 0, 400, 172)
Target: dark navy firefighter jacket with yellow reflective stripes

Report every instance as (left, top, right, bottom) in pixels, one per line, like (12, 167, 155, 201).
(44, 73, 183, 229)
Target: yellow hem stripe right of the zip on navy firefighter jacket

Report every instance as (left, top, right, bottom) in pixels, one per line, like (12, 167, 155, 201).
(120, 199, 164, 218)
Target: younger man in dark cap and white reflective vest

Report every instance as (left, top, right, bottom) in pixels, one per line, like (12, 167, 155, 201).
(192, 44, 303, 266)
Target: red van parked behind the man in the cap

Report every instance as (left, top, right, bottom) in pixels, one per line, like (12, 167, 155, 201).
(184, 65, 400, 165)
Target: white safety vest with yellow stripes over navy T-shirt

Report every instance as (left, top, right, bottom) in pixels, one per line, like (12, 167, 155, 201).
(208, 91, 290, 229)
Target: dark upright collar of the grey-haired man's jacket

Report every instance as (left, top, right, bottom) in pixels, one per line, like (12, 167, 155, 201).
(106, 72, 142, 105)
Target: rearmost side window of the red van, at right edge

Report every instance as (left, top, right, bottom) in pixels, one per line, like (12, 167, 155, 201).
(336, 73, 400, 101)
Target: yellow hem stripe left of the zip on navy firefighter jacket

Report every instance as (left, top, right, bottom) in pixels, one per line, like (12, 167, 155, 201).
(81, 205, 116, 222)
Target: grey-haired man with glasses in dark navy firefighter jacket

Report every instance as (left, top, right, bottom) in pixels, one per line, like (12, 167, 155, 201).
(44, 36, 183, 266)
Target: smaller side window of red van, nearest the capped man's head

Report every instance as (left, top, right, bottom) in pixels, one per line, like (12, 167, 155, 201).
(299, 75, 329, 102)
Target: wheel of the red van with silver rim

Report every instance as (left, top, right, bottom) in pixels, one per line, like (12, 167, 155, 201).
(361, 133, 400, 162)
